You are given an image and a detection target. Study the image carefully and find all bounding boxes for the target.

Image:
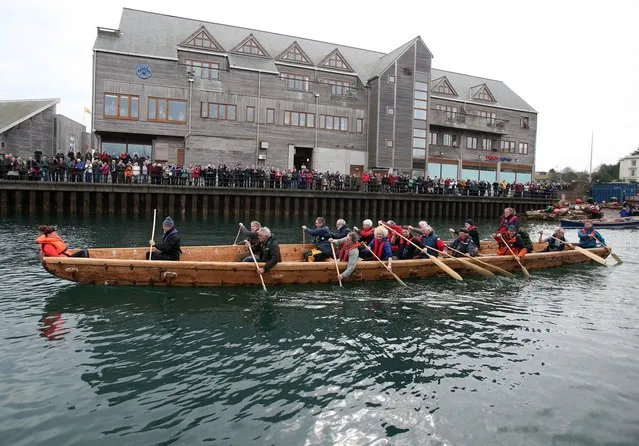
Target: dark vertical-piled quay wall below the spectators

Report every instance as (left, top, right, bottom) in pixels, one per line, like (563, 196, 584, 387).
(0, 181, 553, 224)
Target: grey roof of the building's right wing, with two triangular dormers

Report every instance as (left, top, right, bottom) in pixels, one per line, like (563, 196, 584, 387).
(431, 68, 537, 113)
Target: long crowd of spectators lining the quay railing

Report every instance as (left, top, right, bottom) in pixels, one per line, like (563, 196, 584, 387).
(0, 152, 570, 198)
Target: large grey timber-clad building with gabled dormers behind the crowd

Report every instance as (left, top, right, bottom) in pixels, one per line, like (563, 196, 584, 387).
(92, 8, 537, 181)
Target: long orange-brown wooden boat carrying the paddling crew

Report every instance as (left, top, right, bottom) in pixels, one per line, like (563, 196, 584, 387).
(42, 240, 608, 287)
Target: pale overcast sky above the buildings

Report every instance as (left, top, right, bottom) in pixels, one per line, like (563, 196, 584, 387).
(0, 0, 639, 171)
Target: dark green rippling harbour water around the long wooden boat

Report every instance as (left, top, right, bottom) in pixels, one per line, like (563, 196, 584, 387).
(0, 217, 639, 445)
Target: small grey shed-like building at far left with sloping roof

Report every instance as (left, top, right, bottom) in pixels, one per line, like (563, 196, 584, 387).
(0, 99, 90, 158)
